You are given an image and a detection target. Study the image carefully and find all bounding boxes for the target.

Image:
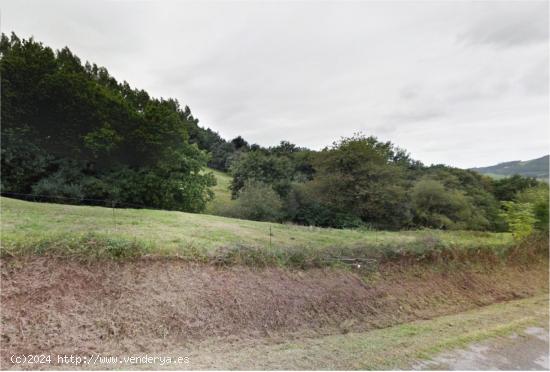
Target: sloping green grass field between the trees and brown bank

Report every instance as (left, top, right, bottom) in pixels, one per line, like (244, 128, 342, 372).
(0, 198, 513, 268)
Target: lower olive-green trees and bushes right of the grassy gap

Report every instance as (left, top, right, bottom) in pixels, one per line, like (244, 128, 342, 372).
(220, 135, 548, 231)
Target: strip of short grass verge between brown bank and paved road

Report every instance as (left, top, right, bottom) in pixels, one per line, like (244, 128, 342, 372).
(184, 294, 548, 370)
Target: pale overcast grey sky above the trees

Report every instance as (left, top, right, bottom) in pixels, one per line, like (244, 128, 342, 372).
(0, 0, 550, 168)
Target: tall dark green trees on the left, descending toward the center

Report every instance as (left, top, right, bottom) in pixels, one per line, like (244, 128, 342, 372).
(0, 34, 245, 212)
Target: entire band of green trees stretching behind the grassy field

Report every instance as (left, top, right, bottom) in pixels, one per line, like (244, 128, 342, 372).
(0, 34, 548, 235)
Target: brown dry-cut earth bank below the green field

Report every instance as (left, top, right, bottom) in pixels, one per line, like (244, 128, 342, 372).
(1, 257, 548, 368)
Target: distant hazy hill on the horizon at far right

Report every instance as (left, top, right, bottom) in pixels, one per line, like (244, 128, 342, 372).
(471, 155, 550, 180)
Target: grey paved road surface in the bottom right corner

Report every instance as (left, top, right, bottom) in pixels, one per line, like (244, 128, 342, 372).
(412, 327, 550, 370)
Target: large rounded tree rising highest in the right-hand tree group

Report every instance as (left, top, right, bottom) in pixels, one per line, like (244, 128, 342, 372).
(310, 135, 411, 229)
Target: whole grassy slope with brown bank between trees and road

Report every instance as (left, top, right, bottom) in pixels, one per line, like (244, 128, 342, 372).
(0, 198, 548, 369)
